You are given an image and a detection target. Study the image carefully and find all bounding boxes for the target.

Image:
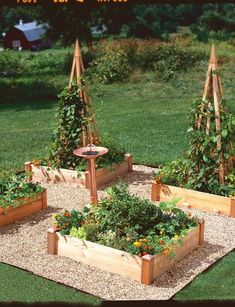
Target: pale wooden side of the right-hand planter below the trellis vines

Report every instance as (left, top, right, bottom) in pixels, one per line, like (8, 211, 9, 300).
(151, 182, 235, 217)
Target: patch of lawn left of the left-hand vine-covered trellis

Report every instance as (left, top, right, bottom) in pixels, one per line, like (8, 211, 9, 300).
(0, 101, 56, 170)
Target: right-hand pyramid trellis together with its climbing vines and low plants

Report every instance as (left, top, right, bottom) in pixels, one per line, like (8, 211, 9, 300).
(155, 45, 235, 195)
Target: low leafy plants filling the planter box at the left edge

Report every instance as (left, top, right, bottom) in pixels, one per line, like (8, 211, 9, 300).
(0, 172, 45, 209)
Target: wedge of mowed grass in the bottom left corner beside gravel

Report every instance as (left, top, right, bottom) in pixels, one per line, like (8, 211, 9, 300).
(0, 263, 102, 306)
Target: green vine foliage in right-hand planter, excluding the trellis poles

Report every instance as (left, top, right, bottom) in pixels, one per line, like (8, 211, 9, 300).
(154, 99, 235, 196)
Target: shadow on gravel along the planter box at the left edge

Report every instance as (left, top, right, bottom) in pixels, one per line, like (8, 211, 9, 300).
(0, 206, 63, 235)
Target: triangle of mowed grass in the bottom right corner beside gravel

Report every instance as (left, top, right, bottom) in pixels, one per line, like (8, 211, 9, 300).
(174, 251, 235, 301)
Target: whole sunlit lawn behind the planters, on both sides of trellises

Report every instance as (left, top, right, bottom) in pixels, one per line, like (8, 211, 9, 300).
(0, 56, 235, 170)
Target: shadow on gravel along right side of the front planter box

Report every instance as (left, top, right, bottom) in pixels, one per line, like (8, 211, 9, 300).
(152, 241, 225, 288)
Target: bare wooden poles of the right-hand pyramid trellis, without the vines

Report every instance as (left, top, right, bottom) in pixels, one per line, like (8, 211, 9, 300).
(197, 44, 233, 184)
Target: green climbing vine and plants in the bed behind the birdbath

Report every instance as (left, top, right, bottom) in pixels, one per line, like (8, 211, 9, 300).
(38, 84, 125, 173)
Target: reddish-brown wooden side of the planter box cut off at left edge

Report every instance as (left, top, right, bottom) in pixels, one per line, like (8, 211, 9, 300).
(0, 190, 47, 226)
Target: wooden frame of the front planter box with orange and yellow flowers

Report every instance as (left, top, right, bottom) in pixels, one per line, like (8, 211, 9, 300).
(47, 220, 204, 285)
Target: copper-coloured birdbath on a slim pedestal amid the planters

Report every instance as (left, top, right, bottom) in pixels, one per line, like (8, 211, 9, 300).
(73, 144, 109, 204)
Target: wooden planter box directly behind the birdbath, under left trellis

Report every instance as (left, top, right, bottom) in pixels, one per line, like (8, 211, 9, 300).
(25, 154, 132, 189)
